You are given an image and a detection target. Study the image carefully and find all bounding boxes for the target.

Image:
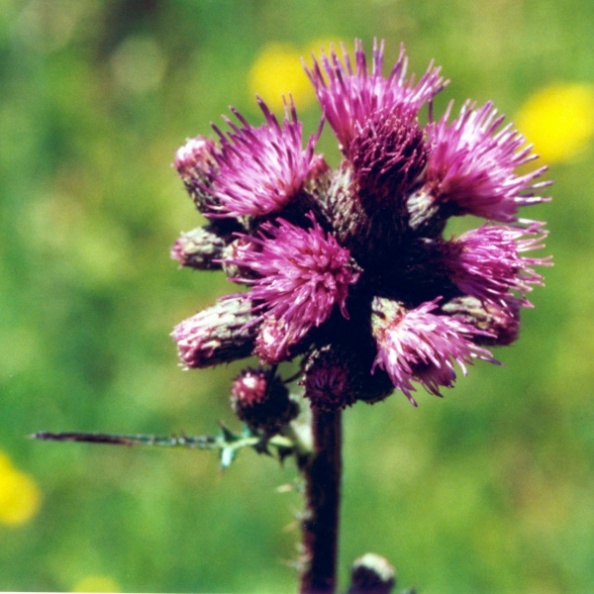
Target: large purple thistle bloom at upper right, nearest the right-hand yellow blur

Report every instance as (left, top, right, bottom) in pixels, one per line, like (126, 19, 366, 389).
(425, 101, 550, 222)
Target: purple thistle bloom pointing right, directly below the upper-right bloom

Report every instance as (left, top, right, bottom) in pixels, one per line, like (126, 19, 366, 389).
(442, 224, 550, 306)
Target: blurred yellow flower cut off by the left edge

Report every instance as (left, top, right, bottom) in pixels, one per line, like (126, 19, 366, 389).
(0, 452, 41, 525)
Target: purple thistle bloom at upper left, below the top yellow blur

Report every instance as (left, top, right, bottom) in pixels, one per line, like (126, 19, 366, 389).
(204, 99, 320, 217)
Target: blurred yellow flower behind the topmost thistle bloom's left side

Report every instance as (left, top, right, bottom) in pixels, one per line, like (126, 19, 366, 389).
(248, 39, 338, 111)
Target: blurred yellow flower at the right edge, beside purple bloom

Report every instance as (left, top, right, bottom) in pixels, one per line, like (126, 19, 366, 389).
(516, 83, 594, 163)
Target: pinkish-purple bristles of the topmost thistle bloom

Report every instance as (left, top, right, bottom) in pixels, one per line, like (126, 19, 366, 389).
(305, 39, 447, 154)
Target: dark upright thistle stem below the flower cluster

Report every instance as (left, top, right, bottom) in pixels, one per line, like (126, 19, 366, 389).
(299, 408, 342, 594)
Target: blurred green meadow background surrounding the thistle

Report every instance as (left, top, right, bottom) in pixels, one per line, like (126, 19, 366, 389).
(0, 0, 594, 594)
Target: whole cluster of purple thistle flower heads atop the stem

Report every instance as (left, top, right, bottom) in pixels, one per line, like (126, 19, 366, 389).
(172, 41, 550, 416)
